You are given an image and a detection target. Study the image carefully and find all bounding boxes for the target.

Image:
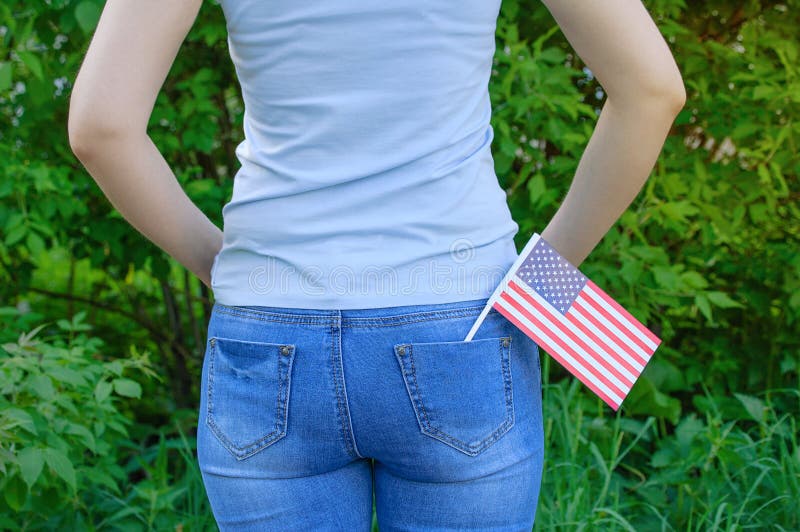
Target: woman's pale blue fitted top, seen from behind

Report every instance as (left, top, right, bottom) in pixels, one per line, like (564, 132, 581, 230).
(212, 0, 518, 309)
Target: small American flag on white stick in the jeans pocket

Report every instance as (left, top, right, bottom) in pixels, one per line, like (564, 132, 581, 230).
(465, 233, 661, 410)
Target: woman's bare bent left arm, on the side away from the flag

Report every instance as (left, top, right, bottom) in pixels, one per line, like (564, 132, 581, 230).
(68, 0, 222, 286)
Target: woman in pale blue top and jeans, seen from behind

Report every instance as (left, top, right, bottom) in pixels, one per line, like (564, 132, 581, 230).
(69, 0, 685, 531)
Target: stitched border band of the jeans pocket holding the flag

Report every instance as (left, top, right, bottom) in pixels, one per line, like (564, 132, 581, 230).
(394, 336, 515, 456)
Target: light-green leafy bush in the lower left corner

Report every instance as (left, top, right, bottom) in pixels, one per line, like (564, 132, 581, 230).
(0, 308, 153, 530)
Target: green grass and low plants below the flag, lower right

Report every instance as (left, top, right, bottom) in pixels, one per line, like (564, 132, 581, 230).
(535, 357, 800, 531)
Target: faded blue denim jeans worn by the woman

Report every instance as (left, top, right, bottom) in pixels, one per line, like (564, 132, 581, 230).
(197, 299, 544, 532)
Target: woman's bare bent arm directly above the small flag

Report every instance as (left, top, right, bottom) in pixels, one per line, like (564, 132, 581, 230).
(542, 0, 686, 266)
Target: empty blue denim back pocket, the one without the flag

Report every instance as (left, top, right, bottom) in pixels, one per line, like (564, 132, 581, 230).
(206, 336, 295, 460)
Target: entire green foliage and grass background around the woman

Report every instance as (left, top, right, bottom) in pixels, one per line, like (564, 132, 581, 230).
(0, 0, 800, 530)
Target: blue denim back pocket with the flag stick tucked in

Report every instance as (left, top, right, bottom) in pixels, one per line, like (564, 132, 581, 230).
(394, 336, 514, 456)
